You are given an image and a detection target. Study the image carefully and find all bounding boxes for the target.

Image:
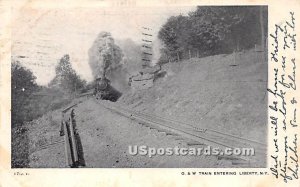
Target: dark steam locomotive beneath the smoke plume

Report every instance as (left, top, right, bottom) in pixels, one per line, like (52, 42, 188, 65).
(94, 77, 122, 102)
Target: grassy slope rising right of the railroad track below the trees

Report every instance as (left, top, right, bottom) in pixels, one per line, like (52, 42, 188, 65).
(119, 51, 267, 141)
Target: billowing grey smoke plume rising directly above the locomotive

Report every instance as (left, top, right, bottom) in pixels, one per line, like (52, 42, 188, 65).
(88, 32, 123, 79)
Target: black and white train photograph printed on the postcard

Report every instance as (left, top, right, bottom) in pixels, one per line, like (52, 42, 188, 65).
(11, 5, 268, 168)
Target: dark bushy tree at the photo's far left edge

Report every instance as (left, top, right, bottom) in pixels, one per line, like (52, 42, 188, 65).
(11, 61, 38, 126)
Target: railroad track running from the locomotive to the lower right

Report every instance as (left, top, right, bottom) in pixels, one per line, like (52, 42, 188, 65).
(97, 100, 267, 166)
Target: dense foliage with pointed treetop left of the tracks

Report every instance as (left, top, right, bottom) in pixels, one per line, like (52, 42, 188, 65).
(11, 55, 86, 127)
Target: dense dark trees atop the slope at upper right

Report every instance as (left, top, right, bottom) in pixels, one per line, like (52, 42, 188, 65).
(158, 6, 268, 63)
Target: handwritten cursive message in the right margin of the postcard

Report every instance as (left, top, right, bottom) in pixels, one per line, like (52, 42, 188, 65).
(267, 12, 299, 183)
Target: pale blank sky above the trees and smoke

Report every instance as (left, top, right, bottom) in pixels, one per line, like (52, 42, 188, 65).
(12, 6, 195, 85)
